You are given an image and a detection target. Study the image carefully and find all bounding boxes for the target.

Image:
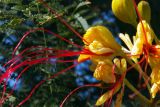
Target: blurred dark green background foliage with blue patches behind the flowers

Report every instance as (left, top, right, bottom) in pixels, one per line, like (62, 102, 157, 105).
(0, 0, 160, 107)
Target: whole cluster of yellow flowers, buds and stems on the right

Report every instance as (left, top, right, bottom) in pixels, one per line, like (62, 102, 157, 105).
(78, 0, 160, 106)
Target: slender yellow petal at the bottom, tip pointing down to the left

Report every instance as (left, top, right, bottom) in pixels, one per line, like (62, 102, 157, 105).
(96, 90, 113, 106)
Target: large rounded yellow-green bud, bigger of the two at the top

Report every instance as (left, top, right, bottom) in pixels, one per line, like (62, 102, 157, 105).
(112, 0, 137, 27)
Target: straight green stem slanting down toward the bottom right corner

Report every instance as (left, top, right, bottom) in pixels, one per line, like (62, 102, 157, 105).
(124, 79, 151, 104)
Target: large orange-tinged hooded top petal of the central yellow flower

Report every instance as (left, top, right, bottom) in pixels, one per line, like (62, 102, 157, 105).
(83, 26, 121, 51)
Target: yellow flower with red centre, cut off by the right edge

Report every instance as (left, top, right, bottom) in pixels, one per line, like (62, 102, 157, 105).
(119, 13, 160, 98)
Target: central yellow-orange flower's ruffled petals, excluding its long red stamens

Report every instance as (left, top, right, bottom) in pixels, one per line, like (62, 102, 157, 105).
(78, 26, 121, 83)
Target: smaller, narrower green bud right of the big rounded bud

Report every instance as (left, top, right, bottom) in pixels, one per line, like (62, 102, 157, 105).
(138, 1, 151, 23)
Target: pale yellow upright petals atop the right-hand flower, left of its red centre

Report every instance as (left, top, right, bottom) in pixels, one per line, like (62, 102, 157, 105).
(119, 20, 155, 56)
